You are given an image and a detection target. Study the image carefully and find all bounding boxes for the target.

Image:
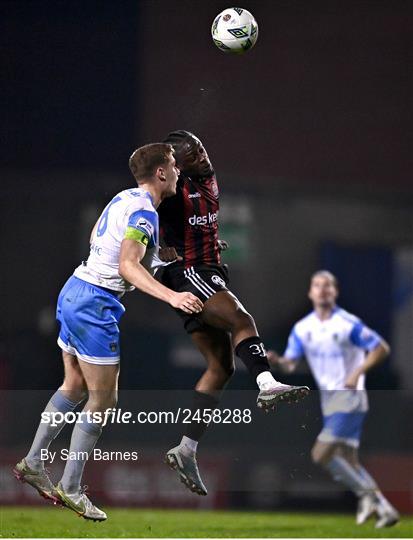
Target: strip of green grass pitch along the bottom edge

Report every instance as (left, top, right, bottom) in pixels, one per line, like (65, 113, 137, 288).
(0, 506, 413, 538)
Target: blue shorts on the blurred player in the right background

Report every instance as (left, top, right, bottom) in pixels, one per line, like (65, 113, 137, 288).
(318, 411, 367, 448)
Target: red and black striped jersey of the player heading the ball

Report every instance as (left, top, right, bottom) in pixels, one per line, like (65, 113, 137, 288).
(158, 174, 220, 268)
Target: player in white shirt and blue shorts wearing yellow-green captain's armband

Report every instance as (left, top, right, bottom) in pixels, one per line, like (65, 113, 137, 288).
(14, 143, 203, 521)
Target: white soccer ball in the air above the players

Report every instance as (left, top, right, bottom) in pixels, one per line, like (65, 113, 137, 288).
(211, 8, 258, 54)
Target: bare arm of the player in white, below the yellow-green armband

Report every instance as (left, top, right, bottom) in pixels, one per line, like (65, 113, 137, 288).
(119, 238, 203, 313)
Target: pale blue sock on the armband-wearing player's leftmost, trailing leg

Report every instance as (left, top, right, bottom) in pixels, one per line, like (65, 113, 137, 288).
(25, 388, 80, 470)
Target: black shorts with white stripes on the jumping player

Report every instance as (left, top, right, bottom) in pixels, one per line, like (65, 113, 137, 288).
(162, 264, 229, 334)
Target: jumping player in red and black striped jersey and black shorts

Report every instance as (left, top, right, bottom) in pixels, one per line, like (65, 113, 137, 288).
(158, 131, 309, 495)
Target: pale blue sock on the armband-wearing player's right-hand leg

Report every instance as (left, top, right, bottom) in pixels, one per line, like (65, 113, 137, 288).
(60, 415, 102, 493)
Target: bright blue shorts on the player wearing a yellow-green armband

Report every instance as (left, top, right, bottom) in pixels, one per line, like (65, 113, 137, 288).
(56, 276, 125, 365)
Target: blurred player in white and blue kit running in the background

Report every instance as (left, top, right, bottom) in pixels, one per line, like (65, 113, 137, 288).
(268, 270, 399, 528)
